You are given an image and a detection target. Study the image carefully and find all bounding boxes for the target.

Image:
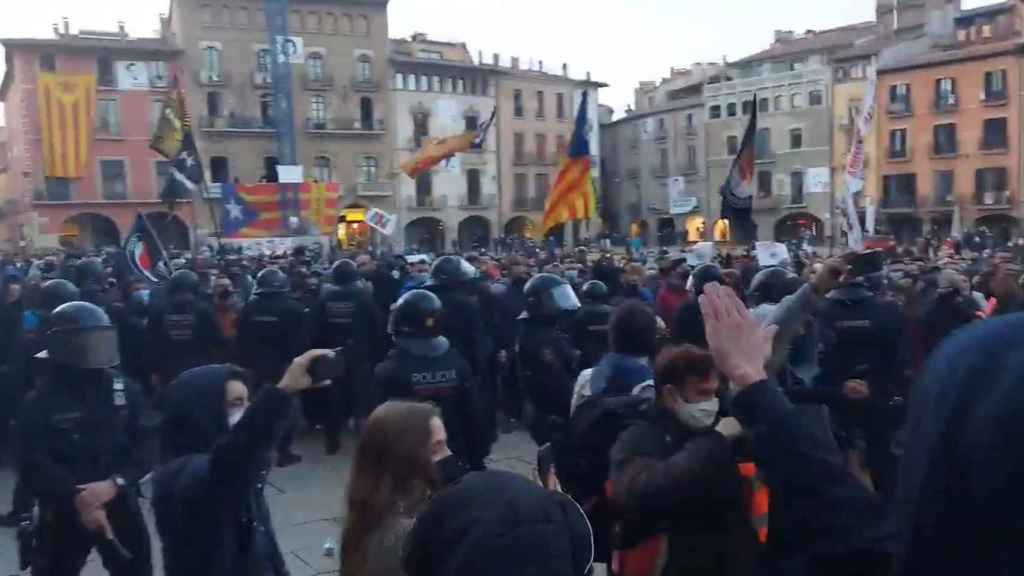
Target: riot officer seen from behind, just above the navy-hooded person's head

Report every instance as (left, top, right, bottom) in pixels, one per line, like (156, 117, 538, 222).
(146, 270, 225, 387)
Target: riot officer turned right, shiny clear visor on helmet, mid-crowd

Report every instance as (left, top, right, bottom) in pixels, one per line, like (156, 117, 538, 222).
(516, 274, 580, 445)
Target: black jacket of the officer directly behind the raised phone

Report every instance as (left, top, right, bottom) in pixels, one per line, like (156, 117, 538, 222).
(311, 286, 384, 363)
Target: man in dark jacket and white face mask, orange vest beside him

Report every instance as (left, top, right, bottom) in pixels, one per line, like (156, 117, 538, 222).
(608, 344, 758, 576)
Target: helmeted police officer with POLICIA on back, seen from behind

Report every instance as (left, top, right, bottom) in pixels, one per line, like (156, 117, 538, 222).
(375, 290, 490, 469)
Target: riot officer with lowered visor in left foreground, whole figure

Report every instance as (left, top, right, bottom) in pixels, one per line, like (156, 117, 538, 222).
(18, 302, 153, 576)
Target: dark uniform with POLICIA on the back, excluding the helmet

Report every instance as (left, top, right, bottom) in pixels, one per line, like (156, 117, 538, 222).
(374, 338, 489, 467)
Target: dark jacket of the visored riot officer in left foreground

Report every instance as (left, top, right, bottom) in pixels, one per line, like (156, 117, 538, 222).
(17, 366, 152, 511)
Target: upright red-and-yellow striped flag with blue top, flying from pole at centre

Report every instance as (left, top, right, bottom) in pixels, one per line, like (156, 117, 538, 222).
(541, 90, 597, 234)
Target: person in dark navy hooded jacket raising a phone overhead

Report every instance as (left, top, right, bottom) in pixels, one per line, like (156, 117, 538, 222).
(153, 351, 331, 576)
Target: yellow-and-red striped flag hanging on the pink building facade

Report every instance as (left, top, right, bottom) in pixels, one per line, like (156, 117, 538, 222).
(36, 72, 96, 178)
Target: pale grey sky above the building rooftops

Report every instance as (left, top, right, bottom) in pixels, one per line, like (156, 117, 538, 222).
(0, 0, 995, 122)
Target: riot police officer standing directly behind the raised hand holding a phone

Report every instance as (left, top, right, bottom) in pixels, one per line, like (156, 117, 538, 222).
(306, 259, 384, 454)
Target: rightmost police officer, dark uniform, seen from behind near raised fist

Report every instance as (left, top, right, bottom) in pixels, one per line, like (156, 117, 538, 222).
(814, 251, 907, 494)
